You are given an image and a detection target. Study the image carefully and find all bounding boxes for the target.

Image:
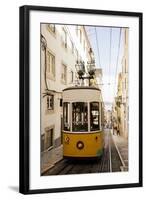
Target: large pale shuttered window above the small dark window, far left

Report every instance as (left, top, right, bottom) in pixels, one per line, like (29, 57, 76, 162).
(47, 51, 55, 78)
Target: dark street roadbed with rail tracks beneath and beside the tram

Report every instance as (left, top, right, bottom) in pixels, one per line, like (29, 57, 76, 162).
(42, 129, 124, 175)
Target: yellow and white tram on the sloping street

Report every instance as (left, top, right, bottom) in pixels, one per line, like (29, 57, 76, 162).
(62, 86, 104, 158)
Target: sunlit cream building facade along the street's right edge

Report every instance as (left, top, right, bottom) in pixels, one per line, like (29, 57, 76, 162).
(113, 28, 129, 138)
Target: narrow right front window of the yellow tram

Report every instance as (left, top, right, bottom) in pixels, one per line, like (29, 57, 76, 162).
(90, 102, 100, 131)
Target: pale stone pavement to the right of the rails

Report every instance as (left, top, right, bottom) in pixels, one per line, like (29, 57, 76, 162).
(112, 135, 128, 171)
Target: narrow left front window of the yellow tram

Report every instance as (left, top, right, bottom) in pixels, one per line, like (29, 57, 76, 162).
(63, 102, 70, 131)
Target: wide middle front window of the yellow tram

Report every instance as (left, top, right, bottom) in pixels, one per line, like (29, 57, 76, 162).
(72, 102, 88, 132)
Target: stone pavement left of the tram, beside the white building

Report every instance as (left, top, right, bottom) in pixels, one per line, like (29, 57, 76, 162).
(41, 145, 63, 174)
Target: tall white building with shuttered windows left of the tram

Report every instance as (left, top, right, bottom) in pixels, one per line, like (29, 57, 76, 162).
(41, 24, 94, 152)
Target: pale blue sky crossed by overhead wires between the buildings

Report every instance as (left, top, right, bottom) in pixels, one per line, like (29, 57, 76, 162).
(85, 26, 123, 109)
